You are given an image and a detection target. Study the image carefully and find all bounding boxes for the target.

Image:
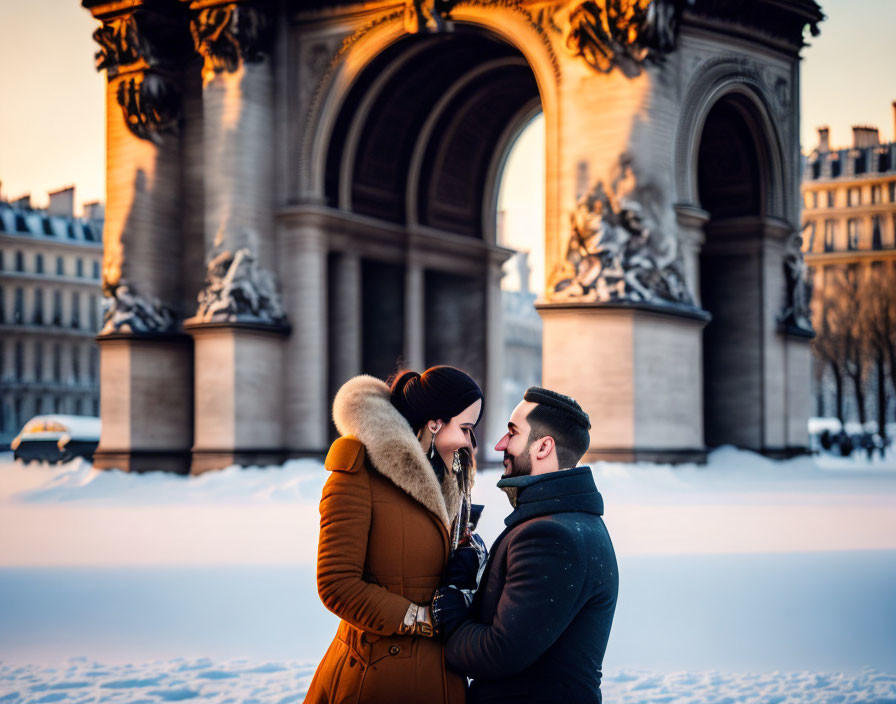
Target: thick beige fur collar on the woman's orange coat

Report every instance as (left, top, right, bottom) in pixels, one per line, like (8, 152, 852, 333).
(333, 374, 460, 533)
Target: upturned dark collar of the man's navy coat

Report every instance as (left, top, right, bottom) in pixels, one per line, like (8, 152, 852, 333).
(498, 467, 604, 527)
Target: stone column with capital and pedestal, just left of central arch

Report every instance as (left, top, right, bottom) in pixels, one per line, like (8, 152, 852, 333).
(187, 0, 289, 473)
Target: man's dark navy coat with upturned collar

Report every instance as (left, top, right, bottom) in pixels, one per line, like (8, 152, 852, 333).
(445, 467, 619, 704)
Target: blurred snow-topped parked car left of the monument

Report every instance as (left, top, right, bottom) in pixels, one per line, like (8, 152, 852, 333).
(10, 415, 100, 464)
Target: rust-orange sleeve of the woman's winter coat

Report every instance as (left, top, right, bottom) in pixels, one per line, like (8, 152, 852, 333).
(317, 467, 411, 635)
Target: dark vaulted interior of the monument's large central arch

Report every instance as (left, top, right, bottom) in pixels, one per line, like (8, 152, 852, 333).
(311, 26, 542, 452)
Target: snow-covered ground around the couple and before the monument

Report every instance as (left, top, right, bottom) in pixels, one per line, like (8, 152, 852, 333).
(0, 448, 896, 703)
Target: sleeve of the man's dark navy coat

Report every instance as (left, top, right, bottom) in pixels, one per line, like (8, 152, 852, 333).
(445, 520, 585, 679)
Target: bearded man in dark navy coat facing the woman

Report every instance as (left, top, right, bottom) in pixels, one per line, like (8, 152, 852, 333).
(434, 387, 619, 704)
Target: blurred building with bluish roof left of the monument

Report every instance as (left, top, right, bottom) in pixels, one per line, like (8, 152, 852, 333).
(0, 187, 103, 447)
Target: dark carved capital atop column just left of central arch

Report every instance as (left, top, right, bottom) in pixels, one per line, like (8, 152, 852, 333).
(190, 0, 274, 74)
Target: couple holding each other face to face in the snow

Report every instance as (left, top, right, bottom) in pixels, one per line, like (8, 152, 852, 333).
(305, 366, 618, 704)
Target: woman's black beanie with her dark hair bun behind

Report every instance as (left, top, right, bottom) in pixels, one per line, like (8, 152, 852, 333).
(391, 366, 482, 435)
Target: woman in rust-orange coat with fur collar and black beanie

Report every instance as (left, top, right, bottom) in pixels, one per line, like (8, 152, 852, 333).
(305, 366, 482, 704)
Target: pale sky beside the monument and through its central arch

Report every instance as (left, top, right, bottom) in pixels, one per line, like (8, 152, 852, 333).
(0, 0, 896, 283)
